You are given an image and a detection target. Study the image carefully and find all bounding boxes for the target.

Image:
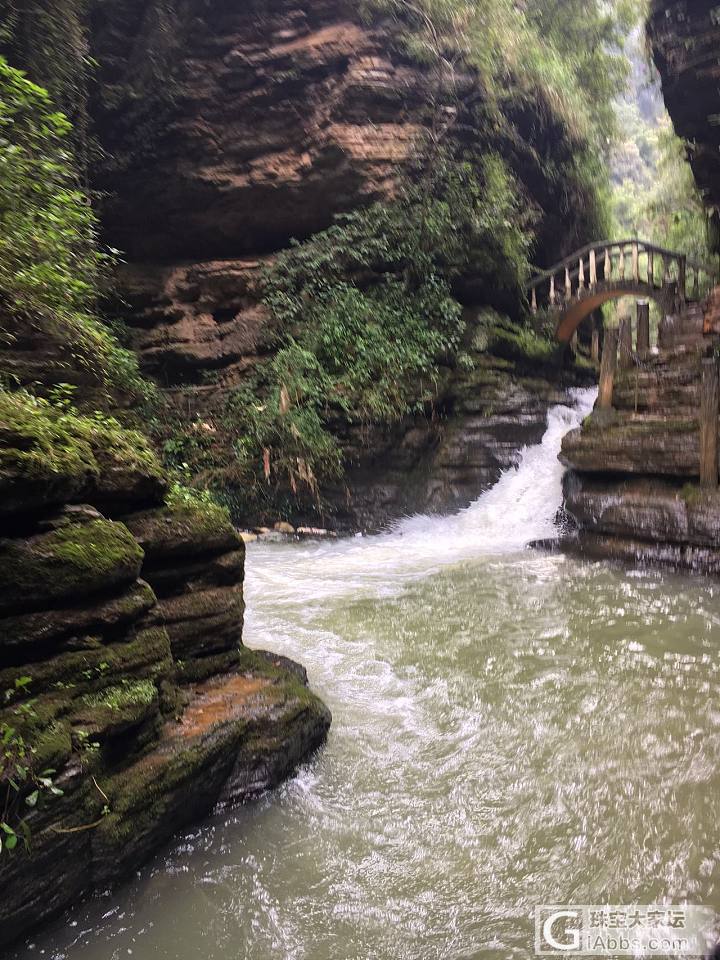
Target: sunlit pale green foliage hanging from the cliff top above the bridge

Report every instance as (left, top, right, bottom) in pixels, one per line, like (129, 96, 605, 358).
(363, 0, 643, 245)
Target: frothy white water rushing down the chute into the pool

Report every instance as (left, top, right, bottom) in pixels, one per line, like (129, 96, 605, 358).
(248, 389, 596, 604)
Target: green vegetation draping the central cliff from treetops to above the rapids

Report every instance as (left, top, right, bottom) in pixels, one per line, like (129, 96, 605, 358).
(205, 0, 631, 510)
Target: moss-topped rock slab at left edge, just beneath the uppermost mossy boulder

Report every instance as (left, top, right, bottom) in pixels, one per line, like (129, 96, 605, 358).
(0, 519, 143, 614)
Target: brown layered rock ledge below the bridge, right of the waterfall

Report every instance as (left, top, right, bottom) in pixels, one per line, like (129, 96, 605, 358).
(561, 300, 720, 573)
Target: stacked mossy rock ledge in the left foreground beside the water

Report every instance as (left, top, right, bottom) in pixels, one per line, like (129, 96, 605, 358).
(0, 394, 330, 945)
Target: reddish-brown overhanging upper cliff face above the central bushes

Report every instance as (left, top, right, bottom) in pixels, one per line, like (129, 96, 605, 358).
(92, 0, 427, 262)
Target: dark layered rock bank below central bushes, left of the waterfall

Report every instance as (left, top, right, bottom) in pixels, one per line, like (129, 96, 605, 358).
(320, 311, 595, 529)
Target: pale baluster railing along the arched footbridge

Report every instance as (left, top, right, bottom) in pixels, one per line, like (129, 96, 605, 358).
(528, 238, 718, 312)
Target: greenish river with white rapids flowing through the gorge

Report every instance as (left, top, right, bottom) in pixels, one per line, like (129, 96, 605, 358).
(15, 392, 720, 960)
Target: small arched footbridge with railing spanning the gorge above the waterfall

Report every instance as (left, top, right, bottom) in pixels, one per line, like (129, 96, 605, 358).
(528, 239, 717, 342)
